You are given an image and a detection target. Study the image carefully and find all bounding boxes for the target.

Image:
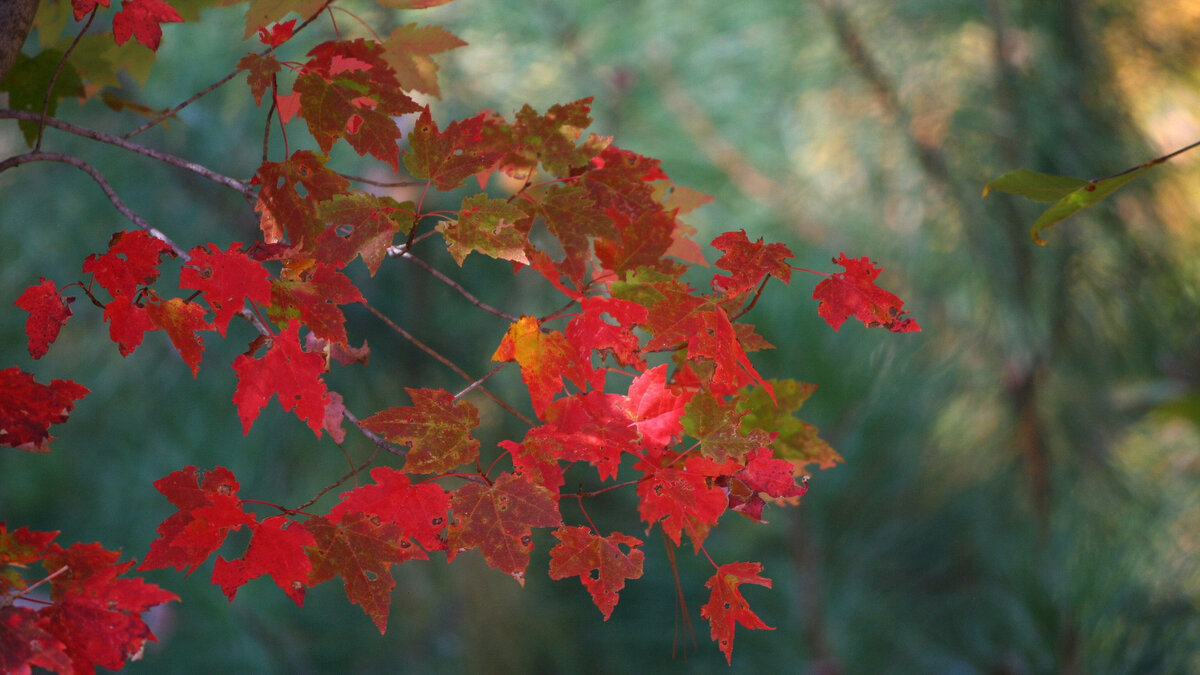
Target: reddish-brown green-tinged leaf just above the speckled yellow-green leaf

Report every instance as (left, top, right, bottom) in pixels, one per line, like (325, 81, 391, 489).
(405, 106, 504, 187)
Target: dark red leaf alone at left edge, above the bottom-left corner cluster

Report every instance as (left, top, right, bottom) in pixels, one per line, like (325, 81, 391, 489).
(0, 368, 90, 453)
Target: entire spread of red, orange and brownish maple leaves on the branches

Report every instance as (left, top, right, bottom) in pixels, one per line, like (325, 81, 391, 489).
(0, 0, 919, 669)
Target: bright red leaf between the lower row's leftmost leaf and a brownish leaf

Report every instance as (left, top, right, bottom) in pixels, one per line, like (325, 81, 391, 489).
(212, 515, 317, 607)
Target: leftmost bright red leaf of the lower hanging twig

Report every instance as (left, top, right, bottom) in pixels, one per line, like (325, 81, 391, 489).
(138, 466, 256, 574)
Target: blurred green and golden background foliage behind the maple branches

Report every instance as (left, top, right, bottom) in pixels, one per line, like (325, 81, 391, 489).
(0, 0, 1200, 674)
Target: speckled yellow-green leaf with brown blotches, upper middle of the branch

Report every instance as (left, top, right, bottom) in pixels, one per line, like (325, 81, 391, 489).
(438, 193, 533, 267)
